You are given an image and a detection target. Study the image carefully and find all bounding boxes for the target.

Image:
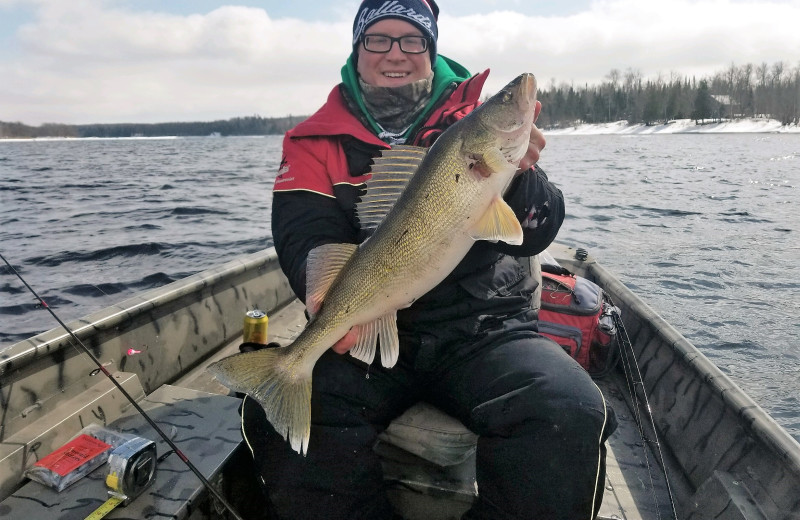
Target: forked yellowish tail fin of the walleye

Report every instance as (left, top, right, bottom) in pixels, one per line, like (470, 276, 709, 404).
(208, 347, 311, 455)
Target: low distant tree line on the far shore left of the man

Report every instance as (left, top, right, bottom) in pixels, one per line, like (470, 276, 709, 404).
(0, 116, 304, 138)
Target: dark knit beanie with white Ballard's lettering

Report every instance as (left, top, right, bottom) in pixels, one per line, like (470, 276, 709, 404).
(353, 0, 439, 63)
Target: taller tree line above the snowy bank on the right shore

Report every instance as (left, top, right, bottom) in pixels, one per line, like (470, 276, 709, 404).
(537, 62, 800, 128)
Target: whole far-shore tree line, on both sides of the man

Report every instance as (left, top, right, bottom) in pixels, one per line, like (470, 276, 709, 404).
(0, 61, 800, 138)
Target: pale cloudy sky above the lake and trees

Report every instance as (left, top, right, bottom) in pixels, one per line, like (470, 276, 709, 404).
(0, 0, 800, 125)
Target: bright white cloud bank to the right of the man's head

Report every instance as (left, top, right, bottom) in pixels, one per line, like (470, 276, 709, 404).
(440, 0, 800, 94)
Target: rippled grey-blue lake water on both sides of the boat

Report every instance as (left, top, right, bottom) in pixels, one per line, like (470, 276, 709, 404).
(0, 134, 800, 440)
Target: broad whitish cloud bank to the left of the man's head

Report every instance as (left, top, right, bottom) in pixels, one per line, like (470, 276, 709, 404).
(0, 1, 350, 123)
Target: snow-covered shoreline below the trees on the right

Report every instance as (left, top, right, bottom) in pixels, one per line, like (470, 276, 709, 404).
(543, 118, 800, 135)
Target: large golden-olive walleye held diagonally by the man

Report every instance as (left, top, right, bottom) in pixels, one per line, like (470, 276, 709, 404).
(209, 73, 536, 454)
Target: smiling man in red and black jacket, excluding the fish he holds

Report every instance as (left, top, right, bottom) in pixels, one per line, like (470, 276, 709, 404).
(242, 0, 611, 520)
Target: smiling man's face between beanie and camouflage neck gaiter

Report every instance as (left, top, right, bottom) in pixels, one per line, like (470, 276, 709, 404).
(357, 18, 431, 87)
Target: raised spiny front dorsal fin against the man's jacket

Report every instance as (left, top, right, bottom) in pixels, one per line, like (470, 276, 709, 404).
(356, 145, 428, 229)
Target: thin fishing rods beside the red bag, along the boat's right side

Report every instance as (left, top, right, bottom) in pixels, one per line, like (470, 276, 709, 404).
(606, 294, 678, 519)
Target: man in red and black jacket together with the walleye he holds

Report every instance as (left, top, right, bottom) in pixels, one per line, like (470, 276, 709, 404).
(212, 0, 614, 520)
